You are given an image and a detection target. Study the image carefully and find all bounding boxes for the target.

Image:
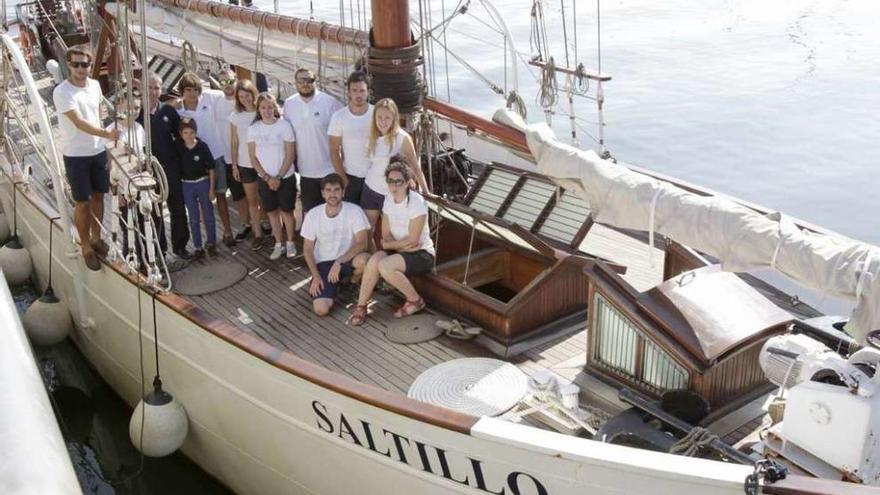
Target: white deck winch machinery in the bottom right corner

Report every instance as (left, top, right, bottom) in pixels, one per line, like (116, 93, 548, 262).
(759, 334, 880, 485)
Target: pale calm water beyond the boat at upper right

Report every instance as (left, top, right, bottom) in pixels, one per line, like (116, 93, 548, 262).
(268, 0, 880, 244)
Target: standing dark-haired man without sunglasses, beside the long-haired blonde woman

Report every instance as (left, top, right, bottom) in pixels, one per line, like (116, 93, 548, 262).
(327, 71, 373, 204)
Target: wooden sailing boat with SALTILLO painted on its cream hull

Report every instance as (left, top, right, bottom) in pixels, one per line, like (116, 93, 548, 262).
(0, 0, 880, 495)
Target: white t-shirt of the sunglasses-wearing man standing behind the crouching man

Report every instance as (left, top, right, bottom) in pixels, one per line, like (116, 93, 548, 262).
(284, 90, 342, 179)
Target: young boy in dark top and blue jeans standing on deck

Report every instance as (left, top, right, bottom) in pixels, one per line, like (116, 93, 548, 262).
(174, 117, 217, 259)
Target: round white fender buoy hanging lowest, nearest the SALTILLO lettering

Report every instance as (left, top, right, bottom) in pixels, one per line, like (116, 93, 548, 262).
(128, 377, 189, 457)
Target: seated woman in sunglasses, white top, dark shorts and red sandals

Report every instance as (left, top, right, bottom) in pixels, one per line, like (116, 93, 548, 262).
(348, 159, 434, 326)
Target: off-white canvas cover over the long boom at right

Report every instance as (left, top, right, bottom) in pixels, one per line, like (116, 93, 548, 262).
(496, 112, 880, 341)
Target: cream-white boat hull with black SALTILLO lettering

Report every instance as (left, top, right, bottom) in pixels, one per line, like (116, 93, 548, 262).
(0, 160, 764, 495)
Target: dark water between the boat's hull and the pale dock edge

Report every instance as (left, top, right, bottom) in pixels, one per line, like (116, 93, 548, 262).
(12, 284, 231, 495)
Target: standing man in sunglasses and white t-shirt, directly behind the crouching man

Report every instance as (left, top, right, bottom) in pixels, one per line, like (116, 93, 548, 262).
(284, 69, 342, 215)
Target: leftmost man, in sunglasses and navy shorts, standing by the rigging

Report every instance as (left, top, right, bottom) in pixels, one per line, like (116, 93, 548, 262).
(52, 48, 119, 271)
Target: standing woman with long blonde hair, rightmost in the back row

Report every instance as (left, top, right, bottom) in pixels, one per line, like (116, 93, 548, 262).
(361, 98, 428, 239)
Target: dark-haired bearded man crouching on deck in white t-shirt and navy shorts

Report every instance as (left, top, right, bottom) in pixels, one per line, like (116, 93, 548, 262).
(301, 174, 370, 316)
